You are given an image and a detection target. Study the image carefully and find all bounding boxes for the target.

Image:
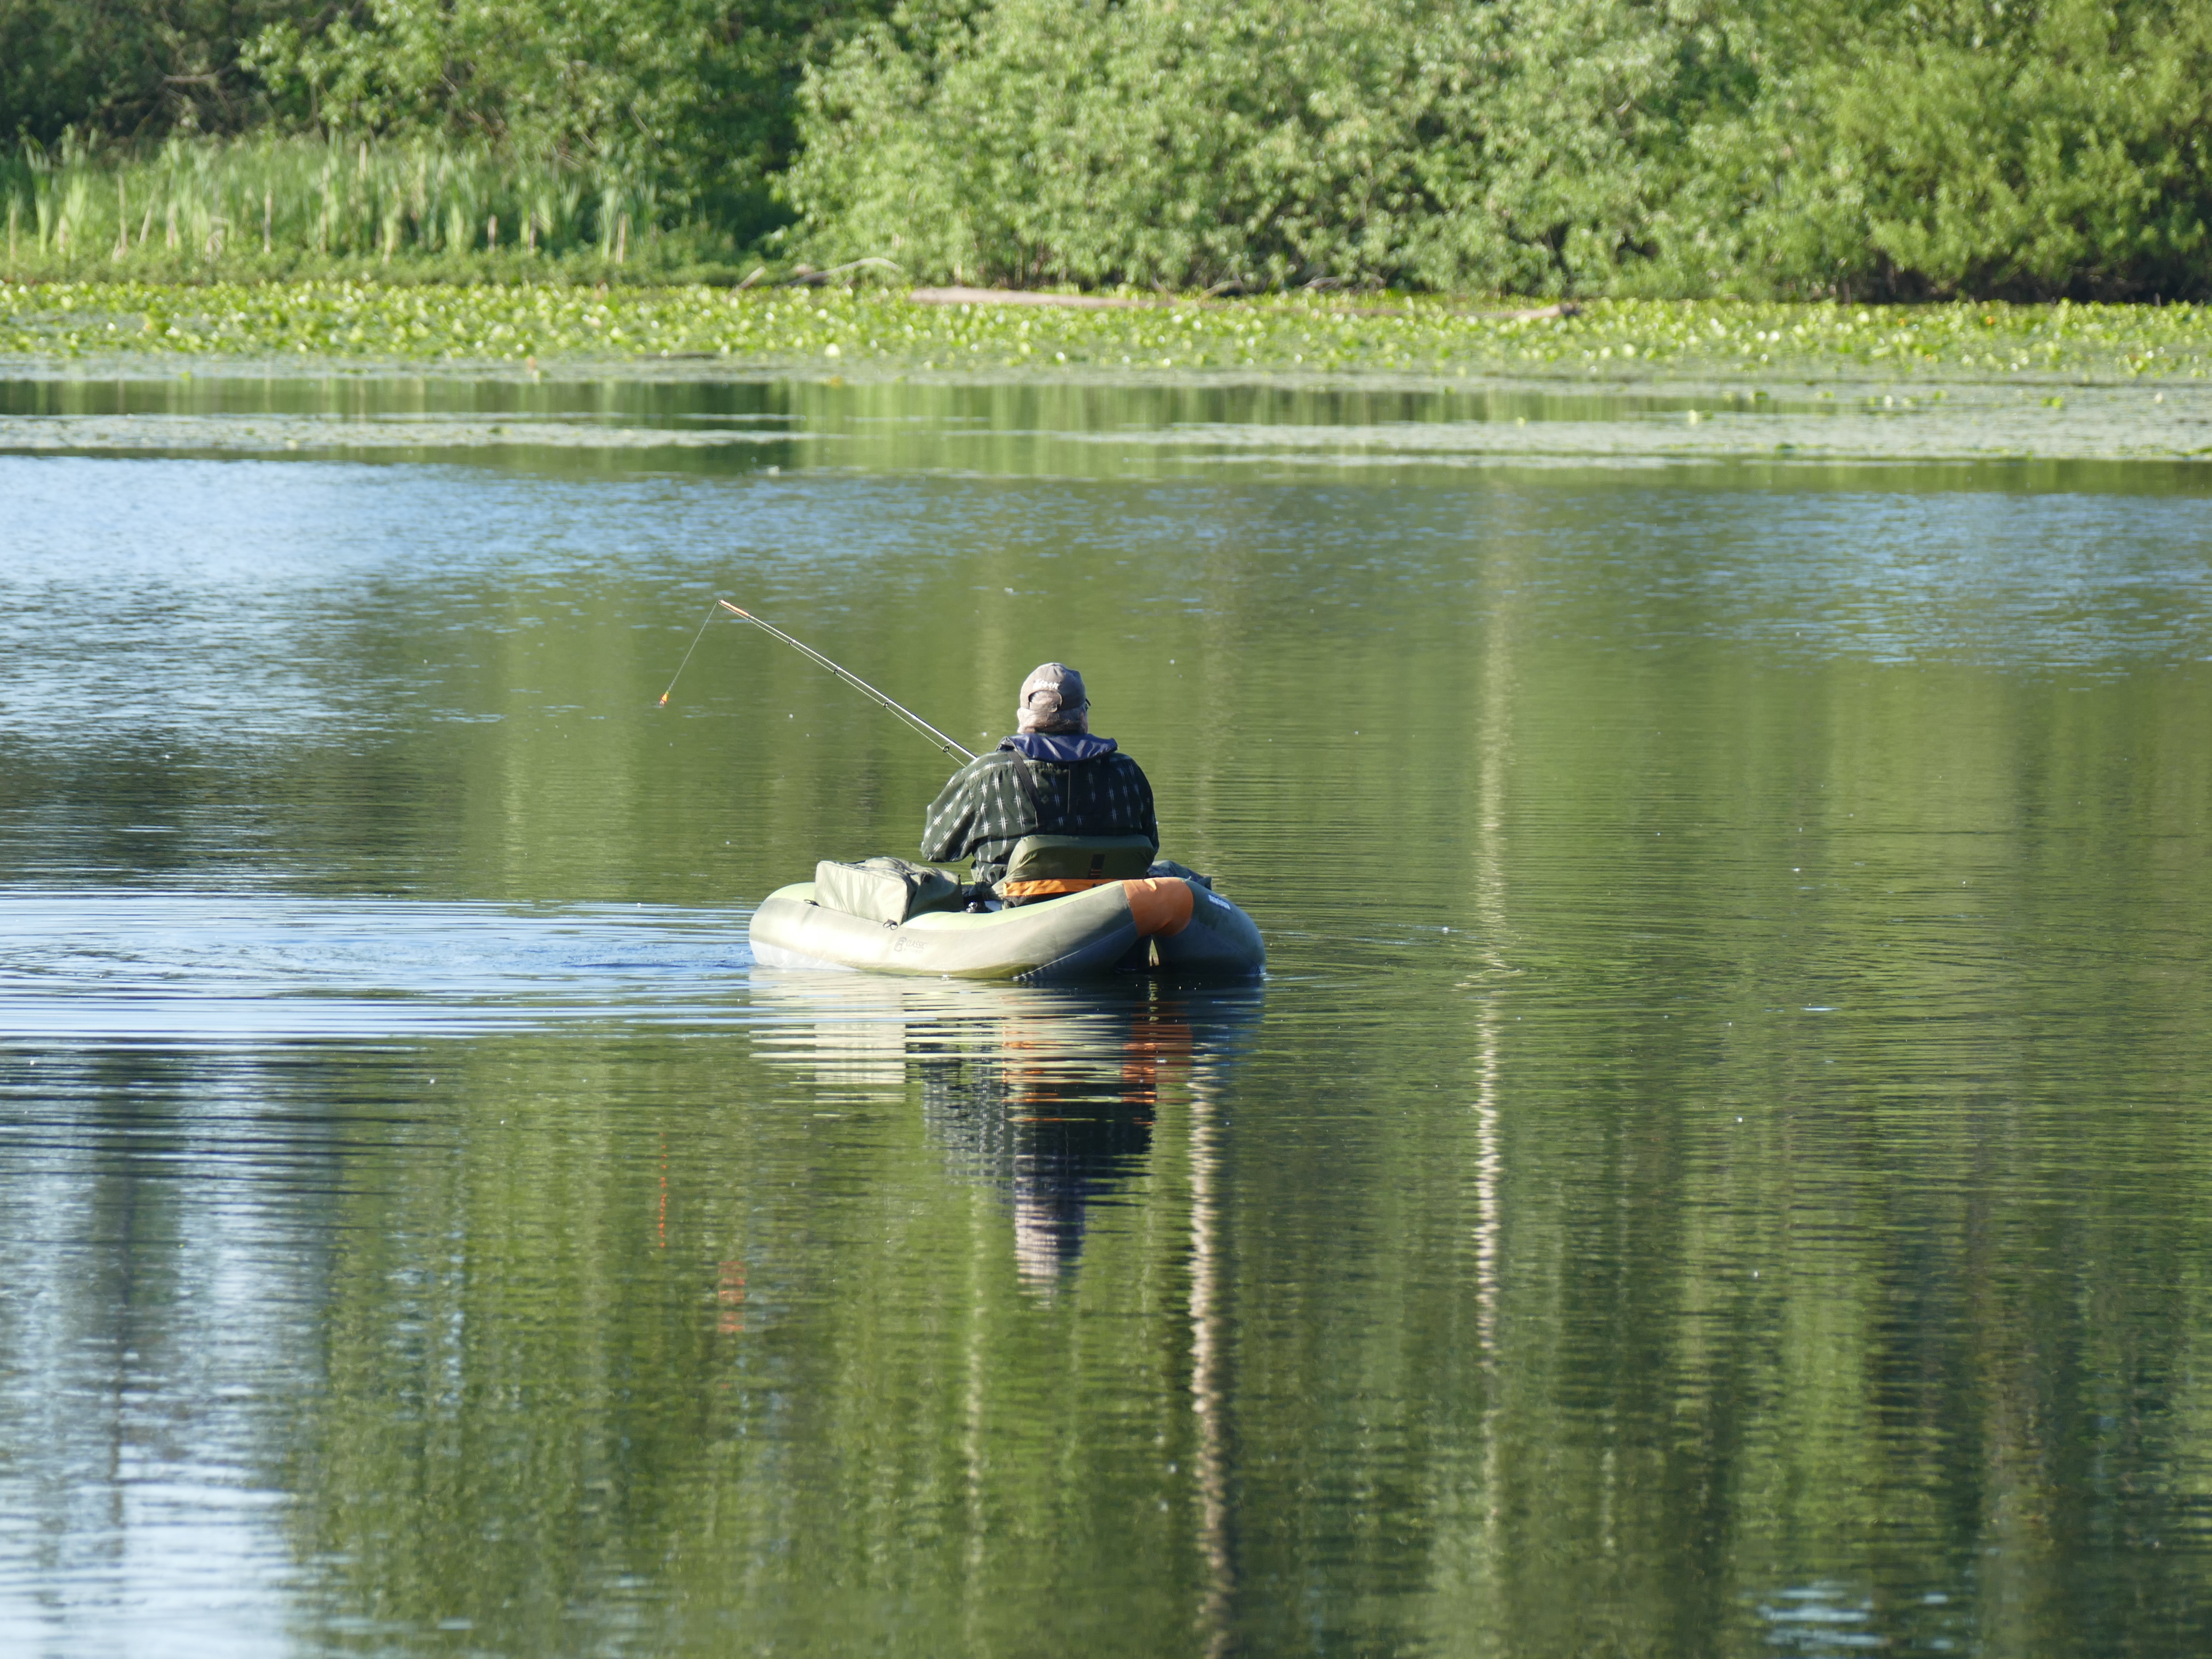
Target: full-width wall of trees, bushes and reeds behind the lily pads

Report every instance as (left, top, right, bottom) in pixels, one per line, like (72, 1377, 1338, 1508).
(0, 0, 2212, 299)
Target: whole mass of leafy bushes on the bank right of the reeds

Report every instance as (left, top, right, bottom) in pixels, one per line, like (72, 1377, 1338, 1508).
(788, 0, 2212, 297)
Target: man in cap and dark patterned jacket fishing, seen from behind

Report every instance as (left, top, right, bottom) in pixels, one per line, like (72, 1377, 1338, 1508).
(922, 661, 1159, 902)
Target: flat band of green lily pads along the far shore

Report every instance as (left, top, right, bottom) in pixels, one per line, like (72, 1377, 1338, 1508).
(0, 270, 2212, 385)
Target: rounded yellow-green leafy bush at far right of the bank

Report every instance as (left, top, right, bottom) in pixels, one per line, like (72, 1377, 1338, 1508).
(1752, 0, 2212, 299)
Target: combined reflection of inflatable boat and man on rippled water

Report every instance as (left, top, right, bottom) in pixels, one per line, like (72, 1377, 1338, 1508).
(754, 973, 1261, 1292)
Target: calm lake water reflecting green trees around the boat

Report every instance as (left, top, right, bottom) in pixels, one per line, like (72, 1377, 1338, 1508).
(0, 378, 2212, 1659)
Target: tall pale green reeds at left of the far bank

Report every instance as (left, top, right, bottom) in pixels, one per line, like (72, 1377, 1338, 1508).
(0, 137, 668, 274)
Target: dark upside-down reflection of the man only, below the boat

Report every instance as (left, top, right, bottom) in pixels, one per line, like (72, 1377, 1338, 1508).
(918, 1024, 1190, 1290)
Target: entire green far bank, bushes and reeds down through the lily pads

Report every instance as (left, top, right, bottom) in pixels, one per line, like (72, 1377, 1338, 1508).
(13, 0, 2212, 385)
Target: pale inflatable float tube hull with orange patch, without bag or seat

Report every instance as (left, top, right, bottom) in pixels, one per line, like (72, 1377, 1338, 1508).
(750, 876, 1267, 984)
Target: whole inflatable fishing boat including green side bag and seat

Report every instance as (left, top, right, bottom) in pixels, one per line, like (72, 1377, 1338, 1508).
(750, 836, 1267, 984)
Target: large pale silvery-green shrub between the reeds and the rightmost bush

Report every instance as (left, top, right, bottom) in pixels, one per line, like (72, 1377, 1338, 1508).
(785, 0, 1743, 290)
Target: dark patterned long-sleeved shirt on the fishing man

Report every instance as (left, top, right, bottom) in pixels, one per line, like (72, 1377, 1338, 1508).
(922, 750, 1159, 880)
